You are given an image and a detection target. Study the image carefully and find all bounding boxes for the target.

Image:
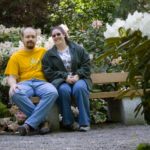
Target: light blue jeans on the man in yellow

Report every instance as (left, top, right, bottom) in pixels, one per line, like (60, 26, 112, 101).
(11, 79, 58, 129)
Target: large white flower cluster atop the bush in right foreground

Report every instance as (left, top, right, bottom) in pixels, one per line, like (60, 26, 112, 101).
(104, 11, 150, 39)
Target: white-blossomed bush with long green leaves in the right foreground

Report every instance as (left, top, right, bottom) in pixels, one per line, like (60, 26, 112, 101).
(97, 11, 150, 124)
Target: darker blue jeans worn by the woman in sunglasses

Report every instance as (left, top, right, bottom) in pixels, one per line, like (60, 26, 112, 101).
(58, 80, 90, 126)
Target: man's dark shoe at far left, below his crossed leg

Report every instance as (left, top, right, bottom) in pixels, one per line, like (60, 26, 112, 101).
(18, 124, 30, 136)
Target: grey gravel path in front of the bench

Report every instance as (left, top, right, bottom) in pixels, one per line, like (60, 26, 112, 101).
(0, 124, 150, 150)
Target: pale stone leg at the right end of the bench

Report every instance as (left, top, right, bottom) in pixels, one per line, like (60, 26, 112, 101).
(108, 97, 145, 125)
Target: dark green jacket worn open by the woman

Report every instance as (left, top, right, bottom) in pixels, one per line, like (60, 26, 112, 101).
(42, 42, 92, 90)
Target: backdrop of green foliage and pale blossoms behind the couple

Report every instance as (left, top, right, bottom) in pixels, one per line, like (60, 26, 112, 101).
(0, 0, 150, 122)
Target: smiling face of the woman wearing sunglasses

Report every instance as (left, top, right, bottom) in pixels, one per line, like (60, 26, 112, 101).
(52, 29, 65, 46)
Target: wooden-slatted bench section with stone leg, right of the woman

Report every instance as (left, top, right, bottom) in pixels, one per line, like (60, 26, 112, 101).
(90, 72, 145, 125)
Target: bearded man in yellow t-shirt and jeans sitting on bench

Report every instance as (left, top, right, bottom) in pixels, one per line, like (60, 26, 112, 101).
(5, 27, 58, 135)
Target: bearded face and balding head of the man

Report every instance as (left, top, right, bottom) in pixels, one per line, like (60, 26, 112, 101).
(22, 28, 37, 50)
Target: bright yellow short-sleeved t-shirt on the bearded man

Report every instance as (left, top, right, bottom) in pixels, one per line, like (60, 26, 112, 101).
(5, 47, 46, 82)
